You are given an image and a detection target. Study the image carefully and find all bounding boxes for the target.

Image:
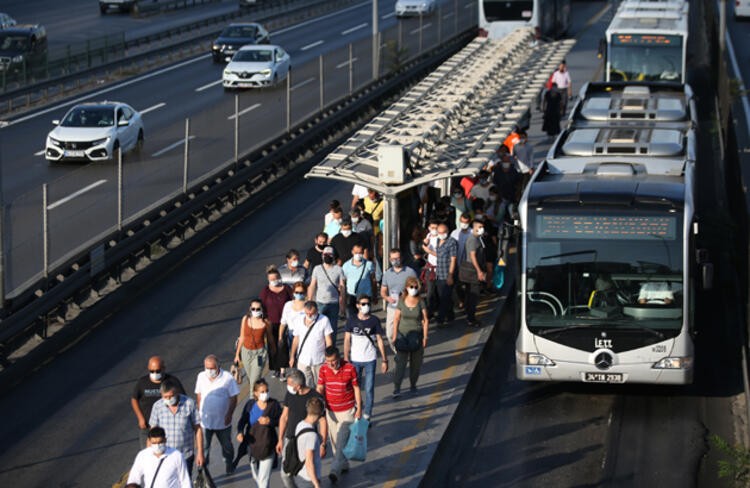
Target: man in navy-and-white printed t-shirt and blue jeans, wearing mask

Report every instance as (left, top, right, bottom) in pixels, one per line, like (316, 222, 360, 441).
(344, 295, 388, 420)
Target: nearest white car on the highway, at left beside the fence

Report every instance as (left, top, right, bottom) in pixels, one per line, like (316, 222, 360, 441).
(44, 102, 143, 161)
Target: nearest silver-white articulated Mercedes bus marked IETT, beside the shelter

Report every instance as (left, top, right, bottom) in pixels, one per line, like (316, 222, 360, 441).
(516, 84, 712, 384)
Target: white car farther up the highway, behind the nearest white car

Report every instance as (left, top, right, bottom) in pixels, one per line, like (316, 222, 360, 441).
(222, 44, 292, 90)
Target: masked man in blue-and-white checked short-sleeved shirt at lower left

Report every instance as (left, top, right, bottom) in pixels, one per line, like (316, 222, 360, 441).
(148, 379, 204, 475)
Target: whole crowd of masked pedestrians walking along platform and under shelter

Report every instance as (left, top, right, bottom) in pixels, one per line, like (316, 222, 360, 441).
(128, 115, 540, 488)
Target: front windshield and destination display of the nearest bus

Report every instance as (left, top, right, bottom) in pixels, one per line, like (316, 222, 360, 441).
(525, 209, 684, 335)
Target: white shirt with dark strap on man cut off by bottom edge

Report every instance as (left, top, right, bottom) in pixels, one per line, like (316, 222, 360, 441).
(128, 447, 193, 488)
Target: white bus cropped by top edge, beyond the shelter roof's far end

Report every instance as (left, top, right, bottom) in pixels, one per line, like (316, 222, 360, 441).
(478, 0, 570, 39)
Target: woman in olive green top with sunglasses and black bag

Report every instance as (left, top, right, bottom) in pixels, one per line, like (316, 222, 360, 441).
(390, 278, 430, 399)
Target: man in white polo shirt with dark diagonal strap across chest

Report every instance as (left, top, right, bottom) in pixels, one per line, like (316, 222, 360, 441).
(289, 301, 334, 385)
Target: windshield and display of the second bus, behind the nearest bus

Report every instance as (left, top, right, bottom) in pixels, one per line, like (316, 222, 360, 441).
(608, 34, 683, 81)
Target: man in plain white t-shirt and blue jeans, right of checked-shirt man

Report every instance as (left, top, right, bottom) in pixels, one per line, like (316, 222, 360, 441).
(195, 354, 240, 474)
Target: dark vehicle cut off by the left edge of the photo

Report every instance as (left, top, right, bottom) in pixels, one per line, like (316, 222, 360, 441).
(0, 24, 47, 73)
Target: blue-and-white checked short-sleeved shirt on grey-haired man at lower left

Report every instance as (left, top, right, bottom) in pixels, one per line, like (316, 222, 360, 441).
(148, 395, 201, 459)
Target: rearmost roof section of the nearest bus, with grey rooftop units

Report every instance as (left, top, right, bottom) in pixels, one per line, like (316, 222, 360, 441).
(569, 82, 697, 127)
